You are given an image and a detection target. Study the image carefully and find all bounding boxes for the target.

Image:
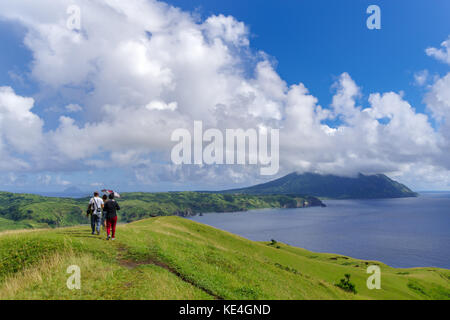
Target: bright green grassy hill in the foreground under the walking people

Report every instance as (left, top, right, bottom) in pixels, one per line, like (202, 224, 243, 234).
(0, 217, 450, 299)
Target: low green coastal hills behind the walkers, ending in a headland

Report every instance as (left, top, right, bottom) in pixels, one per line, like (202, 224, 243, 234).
(0, 192, 322, 231)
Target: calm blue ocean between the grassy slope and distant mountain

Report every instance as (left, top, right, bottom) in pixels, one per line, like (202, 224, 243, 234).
(190, 192, 450, 269)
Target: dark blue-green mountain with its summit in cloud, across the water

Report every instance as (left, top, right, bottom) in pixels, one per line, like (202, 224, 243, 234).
(223, 172, 417, 199)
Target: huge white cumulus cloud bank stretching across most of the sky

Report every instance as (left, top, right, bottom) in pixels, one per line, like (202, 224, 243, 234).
(0, 0, 450, 189)
